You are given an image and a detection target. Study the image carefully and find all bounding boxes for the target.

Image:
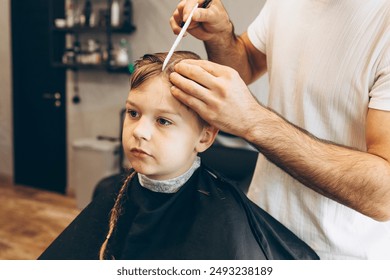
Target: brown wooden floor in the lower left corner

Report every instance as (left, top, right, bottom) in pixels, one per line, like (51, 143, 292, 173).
(0, 180, 80, 260)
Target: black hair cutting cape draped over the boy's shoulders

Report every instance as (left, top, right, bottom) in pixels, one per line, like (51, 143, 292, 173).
(39, 166, 318, 260)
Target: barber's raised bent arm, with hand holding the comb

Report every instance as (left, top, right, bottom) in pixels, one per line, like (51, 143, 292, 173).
(170, 0, 267, 84)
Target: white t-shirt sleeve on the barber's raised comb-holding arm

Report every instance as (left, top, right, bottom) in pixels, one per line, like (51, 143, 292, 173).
(247, 1, 270, 53)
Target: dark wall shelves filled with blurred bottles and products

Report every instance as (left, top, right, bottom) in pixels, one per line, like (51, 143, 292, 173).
(49, 0, 136, 73)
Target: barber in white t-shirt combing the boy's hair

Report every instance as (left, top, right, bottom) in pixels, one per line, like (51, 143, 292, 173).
(170, 0, 390, 259)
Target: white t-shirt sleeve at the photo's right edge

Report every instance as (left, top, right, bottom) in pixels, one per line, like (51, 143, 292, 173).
(368, 42, 390, 111)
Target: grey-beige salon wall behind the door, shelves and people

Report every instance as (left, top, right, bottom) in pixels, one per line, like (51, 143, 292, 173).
(0, 0, 268, 191)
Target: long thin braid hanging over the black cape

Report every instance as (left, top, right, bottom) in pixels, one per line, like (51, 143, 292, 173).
(99, 171, 136, 260)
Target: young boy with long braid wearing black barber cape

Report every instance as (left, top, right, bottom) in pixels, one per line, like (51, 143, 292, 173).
(40, 52, 318, 259)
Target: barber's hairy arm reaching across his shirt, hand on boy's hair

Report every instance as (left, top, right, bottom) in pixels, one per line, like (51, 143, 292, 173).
(171, 60, 390, 221)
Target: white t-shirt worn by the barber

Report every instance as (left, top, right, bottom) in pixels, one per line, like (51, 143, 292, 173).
(248, 0, 390, 259)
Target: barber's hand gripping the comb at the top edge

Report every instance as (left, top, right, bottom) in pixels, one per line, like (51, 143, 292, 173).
(170, 0, 232, 41)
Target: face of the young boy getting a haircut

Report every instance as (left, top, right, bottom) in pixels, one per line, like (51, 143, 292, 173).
(122, 76, 210, 180)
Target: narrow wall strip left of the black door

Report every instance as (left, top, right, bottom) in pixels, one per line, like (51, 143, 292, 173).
(0, 0, 13, 179)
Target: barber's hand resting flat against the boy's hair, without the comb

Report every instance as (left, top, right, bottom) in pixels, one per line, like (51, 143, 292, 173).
(170, 60, 261, 138)
